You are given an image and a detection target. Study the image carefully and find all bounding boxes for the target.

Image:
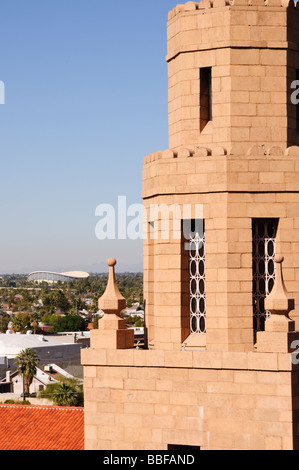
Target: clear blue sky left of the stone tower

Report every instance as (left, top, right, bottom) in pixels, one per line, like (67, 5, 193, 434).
(0, 0, 179, 273)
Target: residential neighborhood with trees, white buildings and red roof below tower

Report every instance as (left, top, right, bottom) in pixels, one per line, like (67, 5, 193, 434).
(0, 274, 144, 450)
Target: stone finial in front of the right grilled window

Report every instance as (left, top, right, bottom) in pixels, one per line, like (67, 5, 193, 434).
(265, 256, 295, 317)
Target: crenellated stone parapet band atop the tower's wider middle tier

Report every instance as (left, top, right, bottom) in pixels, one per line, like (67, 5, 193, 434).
(142, 145, 299, 199)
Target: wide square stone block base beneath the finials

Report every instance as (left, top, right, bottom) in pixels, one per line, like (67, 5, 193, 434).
(82, 349, 299, 450)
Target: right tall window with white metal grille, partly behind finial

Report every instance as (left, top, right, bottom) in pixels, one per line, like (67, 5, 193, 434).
(252, 219, 278, 331)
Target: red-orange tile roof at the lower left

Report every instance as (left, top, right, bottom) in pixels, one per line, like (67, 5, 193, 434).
(0, 404, 84, 450)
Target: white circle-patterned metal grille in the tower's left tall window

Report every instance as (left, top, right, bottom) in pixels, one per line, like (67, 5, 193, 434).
(189, 221, 206, 333)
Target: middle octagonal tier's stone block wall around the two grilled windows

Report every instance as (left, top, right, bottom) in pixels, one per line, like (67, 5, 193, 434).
(143, 146, 299, 351)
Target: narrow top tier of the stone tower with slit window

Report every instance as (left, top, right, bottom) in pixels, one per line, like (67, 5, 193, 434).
(167, 0, 299, 153)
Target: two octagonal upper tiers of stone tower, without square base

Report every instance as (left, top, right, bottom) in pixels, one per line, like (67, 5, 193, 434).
(143, 0, 299, 351)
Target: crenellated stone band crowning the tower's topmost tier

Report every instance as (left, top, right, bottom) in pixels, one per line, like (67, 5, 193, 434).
(167, 0, 299, 62)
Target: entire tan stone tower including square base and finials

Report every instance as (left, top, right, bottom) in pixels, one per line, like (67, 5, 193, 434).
(82, 0, 299, 453)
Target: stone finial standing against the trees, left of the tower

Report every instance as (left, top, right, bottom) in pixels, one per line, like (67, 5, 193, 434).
(98, 258, 126, 315)
